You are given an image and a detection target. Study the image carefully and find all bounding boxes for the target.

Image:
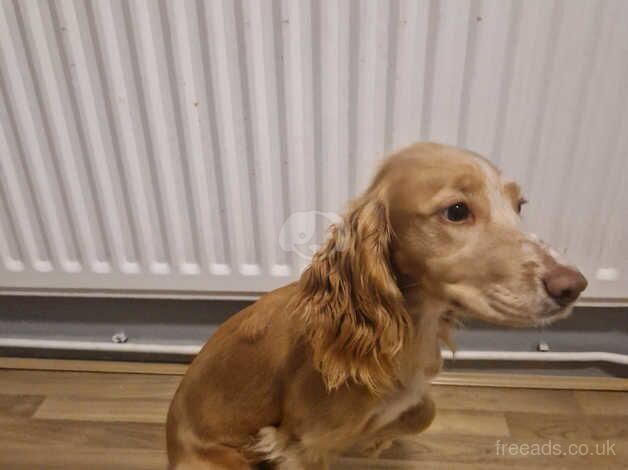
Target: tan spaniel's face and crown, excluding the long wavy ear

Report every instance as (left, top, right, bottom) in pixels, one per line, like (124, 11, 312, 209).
(386, 144, 587, 326)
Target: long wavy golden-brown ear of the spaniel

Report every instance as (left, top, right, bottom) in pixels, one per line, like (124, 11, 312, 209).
(297, 191, 410, 393)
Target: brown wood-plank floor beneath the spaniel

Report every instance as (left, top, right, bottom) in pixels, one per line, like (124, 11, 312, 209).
(0, 369, 628, 470)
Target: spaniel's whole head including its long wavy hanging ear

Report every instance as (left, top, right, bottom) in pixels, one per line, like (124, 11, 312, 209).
(299, 143, 587, 389)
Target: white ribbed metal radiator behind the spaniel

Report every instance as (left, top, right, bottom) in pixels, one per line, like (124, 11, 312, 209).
(0, 0, 628, 301)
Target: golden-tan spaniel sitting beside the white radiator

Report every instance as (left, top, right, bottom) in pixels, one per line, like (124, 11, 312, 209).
(167, 143, 587, 470)
